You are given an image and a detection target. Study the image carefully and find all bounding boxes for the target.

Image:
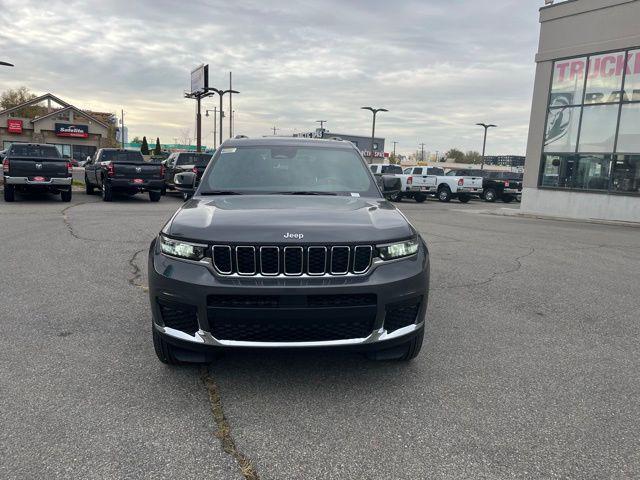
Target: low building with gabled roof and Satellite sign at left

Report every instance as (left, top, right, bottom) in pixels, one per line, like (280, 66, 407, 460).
(0, 93, 116, 161)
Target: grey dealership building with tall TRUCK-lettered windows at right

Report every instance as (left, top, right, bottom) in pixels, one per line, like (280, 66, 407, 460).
(522, 0, 640, 222)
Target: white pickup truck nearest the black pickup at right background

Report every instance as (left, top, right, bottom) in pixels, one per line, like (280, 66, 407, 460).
(399, 166, 482, 203)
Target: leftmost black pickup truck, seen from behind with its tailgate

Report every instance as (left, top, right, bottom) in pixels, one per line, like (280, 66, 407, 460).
(2, 143, 73, 202)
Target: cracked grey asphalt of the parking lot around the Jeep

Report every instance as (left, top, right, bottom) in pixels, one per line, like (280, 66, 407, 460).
(0, 193, 640, 479)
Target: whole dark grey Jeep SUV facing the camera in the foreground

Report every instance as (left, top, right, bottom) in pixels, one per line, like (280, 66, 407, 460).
(149, 138, 429, 364)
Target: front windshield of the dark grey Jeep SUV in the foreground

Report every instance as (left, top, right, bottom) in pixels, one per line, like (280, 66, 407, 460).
(198, 146, 380, 197)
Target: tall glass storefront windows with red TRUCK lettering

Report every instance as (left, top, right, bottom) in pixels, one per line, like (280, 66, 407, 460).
(539, 49, 640, 195)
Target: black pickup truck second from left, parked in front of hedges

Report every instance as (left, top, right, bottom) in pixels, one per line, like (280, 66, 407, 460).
(84, 148, 165, 202)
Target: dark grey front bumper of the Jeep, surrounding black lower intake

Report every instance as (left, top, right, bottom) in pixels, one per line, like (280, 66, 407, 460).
(149, 241, 429, 350)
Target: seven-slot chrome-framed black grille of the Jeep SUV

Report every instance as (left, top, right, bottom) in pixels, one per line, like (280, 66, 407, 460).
(212, 245, 373, 276)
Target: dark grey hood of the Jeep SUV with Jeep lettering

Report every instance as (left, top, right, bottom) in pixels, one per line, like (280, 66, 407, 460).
(162, 195, 415, 245)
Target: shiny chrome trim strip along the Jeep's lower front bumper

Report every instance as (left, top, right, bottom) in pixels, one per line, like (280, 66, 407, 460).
(154, 320, 424, 348)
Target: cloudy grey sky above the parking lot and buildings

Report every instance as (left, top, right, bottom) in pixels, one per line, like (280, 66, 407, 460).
(0, 0, 543, 154)
